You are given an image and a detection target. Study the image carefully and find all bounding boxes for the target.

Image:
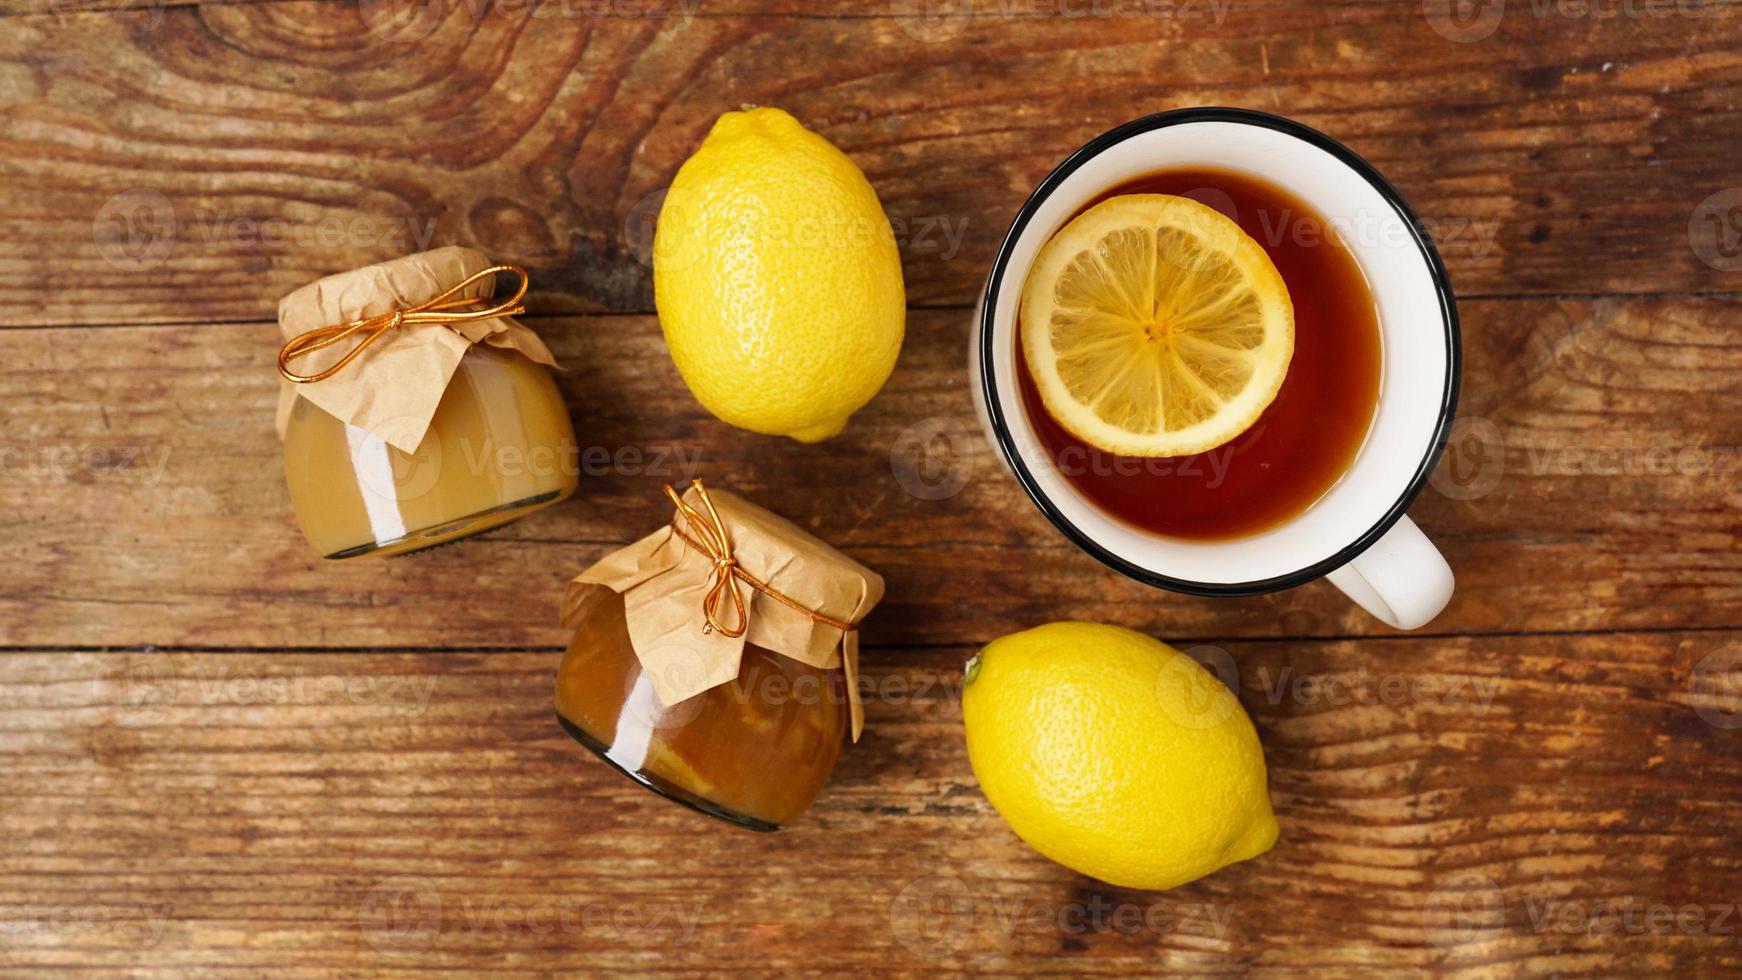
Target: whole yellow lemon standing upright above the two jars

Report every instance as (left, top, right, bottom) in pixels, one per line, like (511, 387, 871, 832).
(653, 108, 906, 442)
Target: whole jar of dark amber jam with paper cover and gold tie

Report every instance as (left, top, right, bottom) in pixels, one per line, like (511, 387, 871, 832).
(556, 486, 883, 830)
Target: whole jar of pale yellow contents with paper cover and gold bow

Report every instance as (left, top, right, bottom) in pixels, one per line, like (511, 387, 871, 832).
(277, 247, 578, 559)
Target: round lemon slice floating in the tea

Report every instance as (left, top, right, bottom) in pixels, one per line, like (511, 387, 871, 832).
(1023, 193, 1294, 456)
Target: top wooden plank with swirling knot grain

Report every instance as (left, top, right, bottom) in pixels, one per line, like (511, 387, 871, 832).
(0, 0, 1742, 324)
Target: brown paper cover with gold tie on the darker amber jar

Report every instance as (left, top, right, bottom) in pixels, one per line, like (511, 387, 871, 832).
(563, 480, 883, 742)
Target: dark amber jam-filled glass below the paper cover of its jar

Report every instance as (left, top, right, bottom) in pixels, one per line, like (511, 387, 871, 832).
(556, 594, 848, 830)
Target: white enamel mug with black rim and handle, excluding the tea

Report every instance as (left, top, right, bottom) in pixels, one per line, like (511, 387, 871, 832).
(969, 108, 1460, 630)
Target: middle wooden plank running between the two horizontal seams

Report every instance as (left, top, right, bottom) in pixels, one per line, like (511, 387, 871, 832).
(0, 299, 1742, 648)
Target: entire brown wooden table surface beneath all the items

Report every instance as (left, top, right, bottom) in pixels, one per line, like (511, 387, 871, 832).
(0, 0, 1742, 978)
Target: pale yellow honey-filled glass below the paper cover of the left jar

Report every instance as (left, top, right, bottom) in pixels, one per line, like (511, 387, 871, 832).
(284, 345, 578, 559)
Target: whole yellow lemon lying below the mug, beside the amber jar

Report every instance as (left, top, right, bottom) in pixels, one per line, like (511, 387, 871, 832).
(962, 623, 1277, 889)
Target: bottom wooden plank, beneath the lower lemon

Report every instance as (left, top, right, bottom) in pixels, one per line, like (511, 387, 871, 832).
(0, 632, 1742, 977)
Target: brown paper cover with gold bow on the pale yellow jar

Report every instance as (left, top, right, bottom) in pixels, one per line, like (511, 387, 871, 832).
(279, 245, 557, 453)
